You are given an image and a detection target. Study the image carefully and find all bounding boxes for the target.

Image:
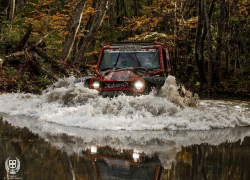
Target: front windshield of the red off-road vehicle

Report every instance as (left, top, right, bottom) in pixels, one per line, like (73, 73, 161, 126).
(99, 49, 160, 70)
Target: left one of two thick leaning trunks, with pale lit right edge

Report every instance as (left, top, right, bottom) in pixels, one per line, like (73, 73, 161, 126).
(61, 0, 86, 61)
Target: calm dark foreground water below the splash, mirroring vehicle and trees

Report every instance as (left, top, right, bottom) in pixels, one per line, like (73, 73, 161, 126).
(0, 116, 250, 180)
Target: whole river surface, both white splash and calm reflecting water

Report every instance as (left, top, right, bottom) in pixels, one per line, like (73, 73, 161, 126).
(0, 77, 250, 180)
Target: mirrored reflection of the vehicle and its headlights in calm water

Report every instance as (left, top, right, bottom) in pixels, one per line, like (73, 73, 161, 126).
(85, 146, 161, 180)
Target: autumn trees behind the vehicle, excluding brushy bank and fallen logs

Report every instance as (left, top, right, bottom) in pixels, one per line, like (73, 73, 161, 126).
(0, 0, 250, 93)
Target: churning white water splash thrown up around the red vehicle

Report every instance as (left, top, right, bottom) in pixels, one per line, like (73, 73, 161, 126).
(0, 76, 250, 130)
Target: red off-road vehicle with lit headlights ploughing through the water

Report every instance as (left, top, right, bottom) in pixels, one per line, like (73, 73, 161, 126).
(85, 42, 170, 96)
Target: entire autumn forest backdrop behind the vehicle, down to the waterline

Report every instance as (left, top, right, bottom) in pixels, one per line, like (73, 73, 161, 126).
(0, 0, 250, 98)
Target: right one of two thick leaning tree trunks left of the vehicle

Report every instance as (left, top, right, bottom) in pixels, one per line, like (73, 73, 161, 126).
(75, 0, 108, 68)
